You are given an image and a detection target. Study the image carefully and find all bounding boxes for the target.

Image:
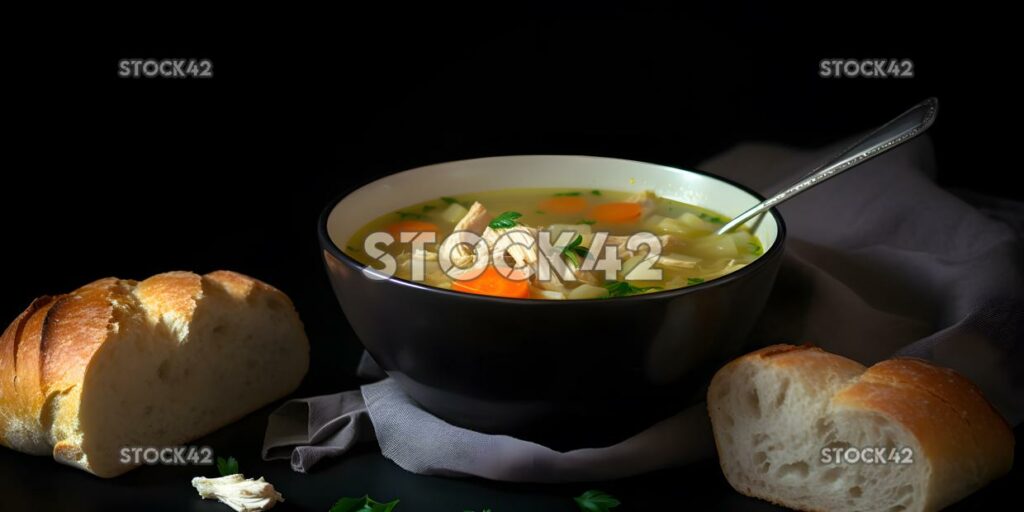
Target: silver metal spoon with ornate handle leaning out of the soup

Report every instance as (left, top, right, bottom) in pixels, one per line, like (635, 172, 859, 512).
(715, 97, 939, 234)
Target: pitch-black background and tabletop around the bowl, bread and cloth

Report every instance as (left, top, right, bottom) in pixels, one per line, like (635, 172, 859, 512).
(0, 7, 1024, 512)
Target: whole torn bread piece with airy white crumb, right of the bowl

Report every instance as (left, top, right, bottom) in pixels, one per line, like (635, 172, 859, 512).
(708, 345, 1014, 512)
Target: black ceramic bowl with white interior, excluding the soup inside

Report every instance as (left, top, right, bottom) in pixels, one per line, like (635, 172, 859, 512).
(319, 156, 785, 445)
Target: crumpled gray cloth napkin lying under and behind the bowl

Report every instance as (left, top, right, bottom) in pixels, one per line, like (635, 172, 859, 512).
(263, 138, 1024, 482)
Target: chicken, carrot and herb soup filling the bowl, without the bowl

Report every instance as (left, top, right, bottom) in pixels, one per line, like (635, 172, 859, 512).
(344, 188, 763, 300)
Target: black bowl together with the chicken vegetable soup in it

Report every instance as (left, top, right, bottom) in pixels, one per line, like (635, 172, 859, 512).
(319, 156, 785, 446)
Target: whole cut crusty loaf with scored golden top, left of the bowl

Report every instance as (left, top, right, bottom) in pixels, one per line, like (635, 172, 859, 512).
(0, 271, 309, 477)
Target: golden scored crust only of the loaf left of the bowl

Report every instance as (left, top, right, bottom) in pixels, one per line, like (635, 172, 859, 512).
(0, 270, 308, 476)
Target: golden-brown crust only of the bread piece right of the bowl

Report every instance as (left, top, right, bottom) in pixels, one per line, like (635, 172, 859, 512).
(708, 345, 1014, 510)
